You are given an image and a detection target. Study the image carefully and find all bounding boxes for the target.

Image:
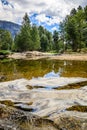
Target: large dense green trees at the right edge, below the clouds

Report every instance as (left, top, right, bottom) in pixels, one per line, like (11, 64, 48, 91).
(60, 6, 87, 52)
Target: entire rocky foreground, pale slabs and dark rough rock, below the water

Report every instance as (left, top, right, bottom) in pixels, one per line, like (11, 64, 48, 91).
(0, 77, 87, 130)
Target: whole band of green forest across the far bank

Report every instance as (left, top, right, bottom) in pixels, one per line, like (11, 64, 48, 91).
(0, 6, 87, 53)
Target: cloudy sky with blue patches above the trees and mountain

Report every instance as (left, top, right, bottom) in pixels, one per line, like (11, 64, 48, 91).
(0, 0, 87, 31)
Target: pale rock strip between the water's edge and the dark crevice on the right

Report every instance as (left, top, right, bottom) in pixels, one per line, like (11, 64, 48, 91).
(28, 77, 87, 88)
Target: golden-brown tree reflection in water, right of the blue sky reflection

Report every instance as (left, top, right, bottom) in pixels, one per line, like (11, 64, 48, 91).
(62, 61, 87, 78)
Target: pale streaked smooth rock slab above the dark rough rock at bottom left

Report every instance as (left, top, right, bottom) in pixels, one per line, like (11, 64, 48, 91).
(0, 77, 87, 130)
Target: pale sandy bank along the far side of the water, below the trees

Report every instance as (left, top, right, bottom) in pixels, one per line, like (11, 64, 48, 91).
(8, 51, 87, 61)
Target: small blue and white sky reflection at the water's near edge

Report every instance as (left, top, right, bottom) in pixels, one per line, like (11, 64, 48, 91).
(44, 68, 63, 78)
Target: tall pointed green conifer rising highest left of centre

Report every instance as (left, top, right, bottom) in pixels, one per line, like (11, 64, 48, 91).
(14, 13, 31, 52)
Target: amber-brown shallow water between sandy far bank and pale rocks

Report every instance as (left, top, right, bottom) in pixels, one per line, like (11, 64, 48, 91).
(0, 59, 87, 82)
